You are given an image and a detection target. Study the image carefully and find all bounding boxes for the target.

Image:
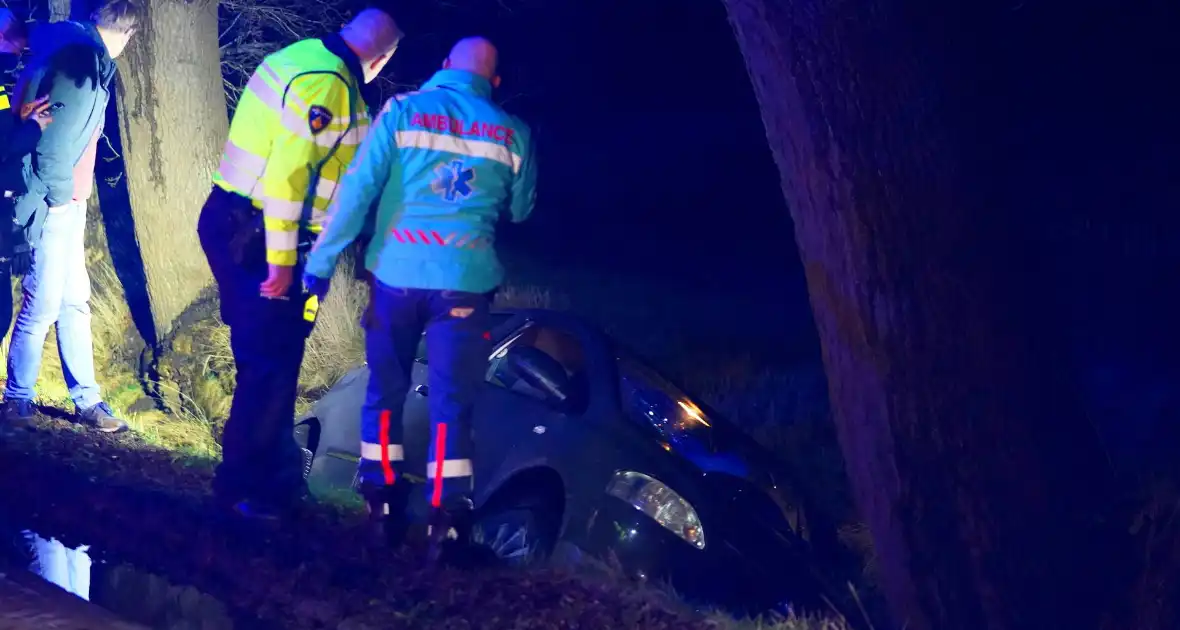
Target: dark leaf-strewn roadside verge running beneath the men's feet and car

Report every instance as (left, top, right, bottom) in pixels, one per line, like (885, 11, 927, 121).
(0, 419, 845, 630)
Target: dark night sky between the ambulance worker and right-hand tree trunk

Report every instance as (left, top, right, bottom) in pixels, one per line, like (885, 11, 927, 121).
(372, 0, 813, 363)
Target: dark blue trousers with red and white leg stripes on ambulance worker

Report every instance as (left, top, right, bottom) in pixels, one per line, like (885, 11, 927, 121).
(358, 282, 492, 507)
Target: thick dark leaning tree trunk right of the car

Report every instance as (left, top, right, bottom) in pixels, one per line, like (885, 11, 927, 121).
(726, 0, 1109, 630)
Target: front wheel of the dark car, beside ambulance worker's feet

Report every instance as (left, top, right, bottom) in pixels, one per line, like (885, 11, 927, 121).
(471, 496, 559, 567)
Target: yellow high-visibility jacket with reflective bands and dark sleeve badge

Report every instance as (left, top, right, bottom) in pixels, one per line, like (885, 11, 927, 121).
(214, 35, 369, 265)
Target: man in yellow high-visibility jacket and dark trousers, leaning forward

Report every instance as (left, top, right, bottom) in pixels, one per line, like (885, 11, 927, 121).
(197, 7, 402, 518)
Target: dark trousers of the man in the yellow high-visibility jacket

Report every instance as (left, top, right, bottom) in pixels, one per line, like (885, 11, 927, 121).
(197, 186, 310, 504)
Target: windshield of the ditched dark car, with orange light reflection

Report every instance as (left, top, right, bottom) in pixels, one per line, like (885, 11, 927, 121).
(617, 353, 710, 438)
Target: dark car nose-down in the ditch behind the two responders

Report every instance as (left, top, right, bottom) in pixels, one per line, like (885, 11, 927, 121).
(296, 310, 838, 612)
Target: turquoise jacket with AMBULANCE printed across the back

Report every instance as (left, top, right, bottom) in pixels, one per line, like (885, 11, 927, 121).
(307, 70, 537, 293)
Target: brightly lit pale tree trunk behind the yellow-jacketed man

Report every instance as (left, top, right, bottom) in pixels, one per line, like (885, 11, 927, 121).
(118, 0, 229, 342)
